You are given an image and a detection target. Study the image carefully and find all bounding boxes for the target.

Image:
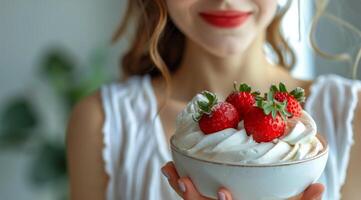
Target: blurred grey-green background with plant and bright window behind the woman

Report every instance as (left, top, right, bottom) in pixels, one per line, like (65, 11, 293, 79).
(0, 0, 361, 200)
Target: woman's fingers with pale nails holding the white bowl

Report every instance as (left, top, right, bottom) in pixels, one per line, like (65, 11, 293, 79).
(162, 162, 324, 200)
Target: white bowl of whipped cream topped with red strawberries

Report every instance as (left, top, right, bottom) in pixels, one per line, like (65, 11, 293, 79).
(171, 83, 328, 200)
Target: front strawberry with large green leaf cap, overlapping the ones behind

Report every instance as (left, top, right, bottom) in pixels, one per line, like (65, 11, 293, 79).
(244, 91, 289, 143)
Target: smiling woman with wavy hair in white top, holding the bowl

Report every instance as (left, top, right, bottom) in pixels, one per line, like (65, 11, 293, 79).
(67, 0, 361, 200)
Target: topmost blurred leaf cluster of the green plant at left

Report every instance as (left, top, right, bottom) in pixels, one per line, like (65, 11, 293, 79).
(40, 47, 109, 108)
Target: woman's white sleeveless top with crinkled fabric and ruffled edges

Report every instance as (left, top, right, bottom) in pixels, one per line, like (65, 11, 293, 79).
(101, 75, 361, 200)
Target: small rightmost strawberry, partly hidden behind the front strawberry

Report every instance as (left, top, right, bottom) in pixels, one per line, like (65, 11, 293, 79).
(271, 83, 305, 117)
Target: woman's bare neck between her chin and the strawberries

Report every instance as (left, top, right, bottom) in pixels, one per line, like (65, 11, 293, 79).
(171, 35, 275, 101)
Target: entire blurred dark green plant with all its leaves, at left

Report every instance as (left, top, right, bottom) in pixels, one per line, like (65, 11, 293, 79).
(0, 48, 109, 199)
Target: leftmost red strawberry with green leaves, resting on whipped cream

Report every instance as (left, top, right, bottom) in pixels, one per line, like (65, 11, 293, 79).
(193, 91, 239, 134)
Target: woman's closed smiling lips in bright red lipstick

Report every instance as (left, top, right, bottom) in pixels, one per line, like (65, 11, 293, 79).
(199, 10, 251, 28)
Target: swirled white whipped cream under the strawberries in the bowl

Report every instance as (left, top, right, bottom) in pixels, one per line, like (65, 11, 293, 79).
(173, 95, 323, 164)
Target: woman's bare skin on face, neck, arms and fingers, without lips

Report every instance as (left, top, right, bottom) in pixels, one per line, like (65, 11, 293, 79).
(67, 0, 361, 200)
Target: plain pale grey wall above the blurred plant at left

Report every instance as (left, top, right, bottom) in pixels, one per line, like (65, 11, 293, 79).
(0, 0, 124, 103)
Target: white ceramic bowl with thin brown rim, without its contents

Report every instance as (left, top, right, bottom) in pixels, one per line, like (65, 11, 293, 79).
(171, 134, 329, 200)
